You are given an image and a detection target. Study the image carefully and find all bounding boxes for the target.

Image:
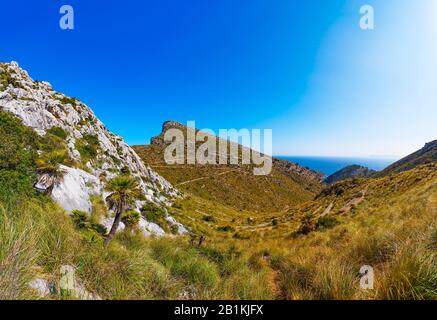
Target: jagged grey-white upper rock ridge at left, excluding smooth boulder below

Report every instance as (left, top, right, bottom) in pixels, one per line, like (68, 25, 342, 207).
(0, 62, 179, 203)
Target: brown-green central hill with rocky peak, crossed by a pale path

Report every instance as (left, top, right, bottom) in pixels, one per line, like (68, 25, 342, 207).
(133, 121, 322, 212)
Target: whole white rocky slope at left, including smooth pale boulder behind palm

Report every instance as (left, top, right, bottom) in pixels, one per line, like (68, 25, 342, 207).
(0, 62, 179, 234)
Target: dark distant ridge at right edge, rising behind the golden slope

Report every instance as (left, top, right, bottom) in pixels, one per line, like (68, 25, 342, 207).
(376, 140, 437, 176)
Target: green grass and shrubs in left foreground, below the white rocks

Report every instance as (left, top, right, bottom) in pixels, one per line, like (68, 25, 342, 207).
(0, 113, 270, 299)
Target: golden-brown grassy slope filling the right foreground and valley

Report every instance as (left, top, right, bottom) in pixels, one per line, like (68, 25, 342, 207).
(158, 164, 437, 299)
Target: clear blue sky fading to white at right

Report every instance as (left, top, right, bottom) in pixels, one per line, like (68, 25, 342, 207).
(0, 0, 437, 157)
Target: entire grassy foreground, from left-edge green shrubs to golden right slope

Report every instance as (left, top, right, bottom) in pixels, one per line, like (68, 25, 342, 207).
(0, 110, 437, 299)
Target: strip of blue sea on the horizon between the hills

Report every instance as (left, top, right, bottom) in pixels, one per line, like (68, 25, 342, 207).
(276, 156, 398, 176)
